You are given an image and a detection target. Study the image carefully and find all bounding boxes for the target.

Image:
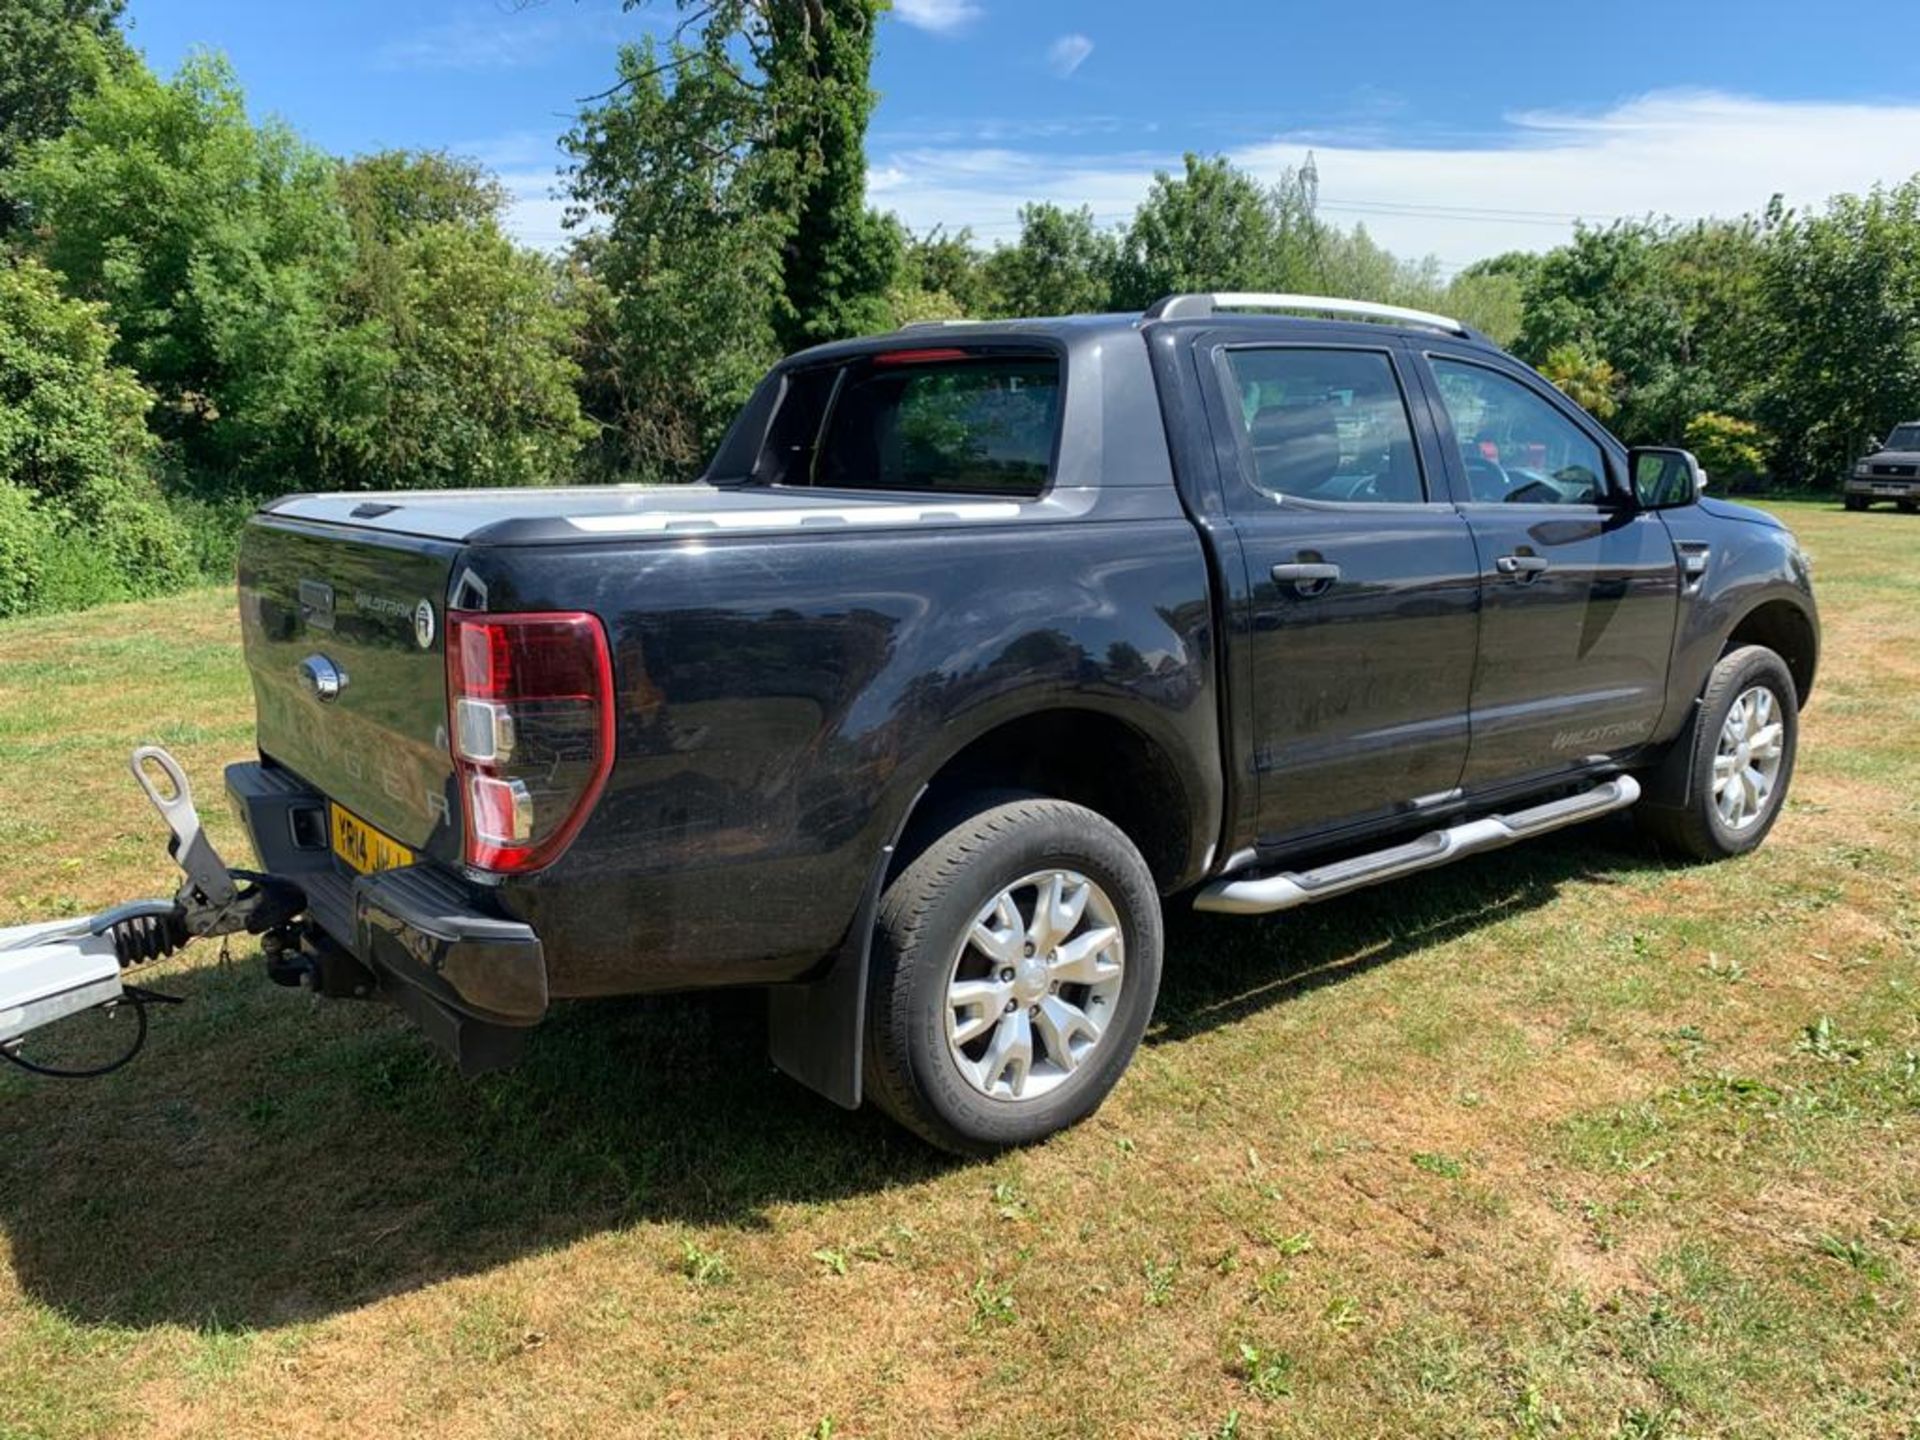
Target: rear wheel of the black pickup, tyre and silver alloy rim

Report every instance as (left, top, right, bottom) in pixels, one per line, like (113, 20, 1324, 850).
(866, 797, 1162, 1154)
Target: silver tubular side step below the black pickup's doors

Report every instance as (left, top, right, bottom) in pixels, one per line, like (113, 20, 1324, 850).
(1194, 776, 1640, 916)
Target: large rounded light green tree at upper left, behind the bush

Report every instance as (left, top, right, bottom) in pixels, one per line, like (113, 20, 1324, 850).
(17, 56, 386, 490)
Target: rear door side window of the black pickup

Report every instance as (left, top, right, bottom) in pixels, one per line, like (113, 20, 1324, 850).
(1227, 349, 1427, 505)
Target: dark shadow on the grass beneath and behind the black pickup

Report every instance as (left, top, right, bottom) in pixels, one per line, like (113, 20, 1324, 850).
(0, 817, 1659, 1329)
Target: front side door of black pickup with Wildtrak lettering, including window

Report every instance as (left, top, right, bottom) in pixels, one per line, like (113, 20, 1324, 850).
(1425, 349, 1680, 789)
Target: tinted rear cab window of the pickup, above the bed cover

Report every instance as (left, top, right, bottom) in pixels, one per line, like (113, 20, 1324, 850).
(755, 349, 1062, 499)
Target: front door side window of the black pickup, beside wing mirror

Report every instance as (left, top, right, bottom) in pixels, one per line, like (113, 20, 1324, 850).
(1432, 355, 1607, 505)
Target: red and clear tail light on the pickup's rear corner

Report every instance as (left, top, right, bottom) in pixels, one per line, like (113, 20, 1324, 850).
(447, 611, 612, 874)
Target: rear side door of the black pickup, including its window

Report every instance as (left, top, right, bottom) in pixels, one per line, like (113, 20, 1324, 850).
(1204, 344, 1478, 847)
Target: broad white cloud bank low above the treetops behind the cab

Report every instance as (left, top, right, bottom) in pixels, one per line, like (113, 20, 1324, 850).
(874, 90, 1920, 269)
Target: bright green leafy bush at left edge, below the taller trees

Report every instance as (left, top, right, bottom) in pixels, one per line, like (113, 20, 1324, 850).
(0, 259, 190, 614)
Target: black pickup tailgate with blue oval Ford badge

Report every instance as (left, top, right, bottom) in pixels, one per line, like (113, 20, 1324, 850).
(238, 515, 461, 860)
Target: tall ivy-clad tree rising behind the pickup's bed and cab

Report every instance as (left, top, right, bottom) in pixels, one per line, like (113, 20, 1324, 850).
(564, 0, 898, 478)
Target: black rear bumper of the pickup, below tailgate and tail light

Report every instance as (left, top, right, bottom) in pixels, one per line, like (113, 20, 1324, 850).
(227, 762, 547, 1029)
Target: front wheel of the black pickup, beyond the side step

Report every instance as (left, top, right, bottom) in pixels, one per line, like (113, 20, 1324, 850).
(1634, 645, 1799, 860)
